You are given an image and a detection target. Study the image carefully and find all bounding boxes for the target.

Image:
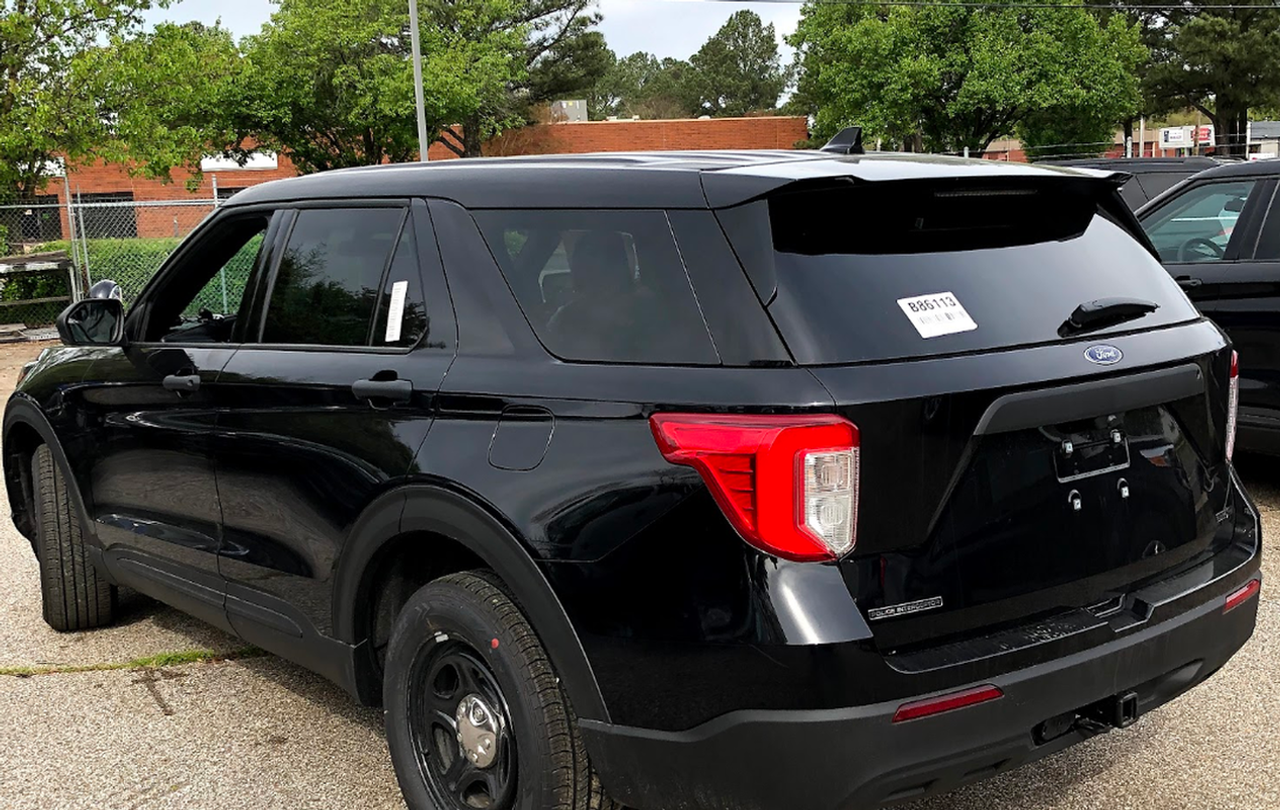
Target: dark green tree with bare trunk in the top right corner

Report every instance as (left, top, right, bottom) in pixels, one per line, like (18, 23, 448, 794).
(1143, 0, 1280, 155)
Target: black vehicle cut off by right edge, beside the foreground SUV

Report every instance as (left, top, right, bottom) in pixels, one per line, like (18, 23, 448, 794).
(1138, 160, 1280, 454)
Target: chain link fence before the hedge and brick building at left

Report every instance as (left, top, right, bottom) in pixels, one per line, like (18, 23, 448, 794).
(0, 195, 216, 328)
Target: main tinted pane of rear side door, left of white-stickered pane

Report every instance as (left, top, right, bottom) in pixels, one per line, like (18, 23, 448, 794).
(262, 207, 404, 345)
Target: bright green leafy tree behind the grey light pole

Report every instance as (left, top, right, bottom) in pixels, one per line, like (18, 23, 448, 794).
(242, 0, 525, 171)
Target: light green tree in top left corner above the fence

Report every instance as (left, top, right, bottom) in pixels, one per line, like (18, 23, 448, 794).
(0, 0, 166, 198)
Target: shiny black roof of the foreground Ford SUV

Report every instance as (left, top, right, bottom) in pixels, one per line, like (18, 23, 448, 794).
(227, 150, 1121, 209)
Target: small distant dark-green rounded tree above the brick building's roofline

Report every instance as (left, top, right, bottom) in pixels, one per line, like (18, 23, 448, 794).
(689, 9, 787, 115)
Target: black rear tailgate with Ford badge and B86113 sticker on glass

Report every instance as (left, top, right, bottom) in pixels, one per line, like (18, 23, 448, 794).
(719, 175, 1231, 650)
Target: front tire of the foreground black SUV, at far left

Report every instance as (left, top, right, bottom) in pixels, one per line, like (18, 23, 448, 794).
(31, 444, 115, 632)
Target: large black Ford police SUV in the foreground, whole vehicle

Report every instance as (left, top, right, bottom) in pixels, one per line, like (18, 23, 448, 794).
(4, 152, 1261, 810)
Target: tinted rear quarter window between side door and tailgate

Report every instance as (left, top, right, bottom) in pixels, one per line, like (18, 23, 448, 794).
(476, 211, 719, 365)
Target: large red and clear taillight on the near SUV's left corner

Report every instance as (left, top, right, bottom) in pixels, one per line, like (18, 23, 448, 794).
(649, 413, 859, 562)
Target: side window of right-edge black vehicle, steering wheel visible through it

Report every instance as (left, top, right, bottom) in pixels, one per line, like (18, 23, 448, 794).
(1143, 180, 1257, 262)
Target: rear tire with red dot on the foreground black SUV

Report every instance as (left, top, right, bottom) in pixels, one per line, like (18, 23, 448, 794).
(383, 572, 621, 810)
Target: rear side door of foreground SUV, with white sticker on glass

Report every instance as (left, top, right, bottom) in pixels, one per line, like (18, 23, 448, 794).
(216, 200, 456, 647)
